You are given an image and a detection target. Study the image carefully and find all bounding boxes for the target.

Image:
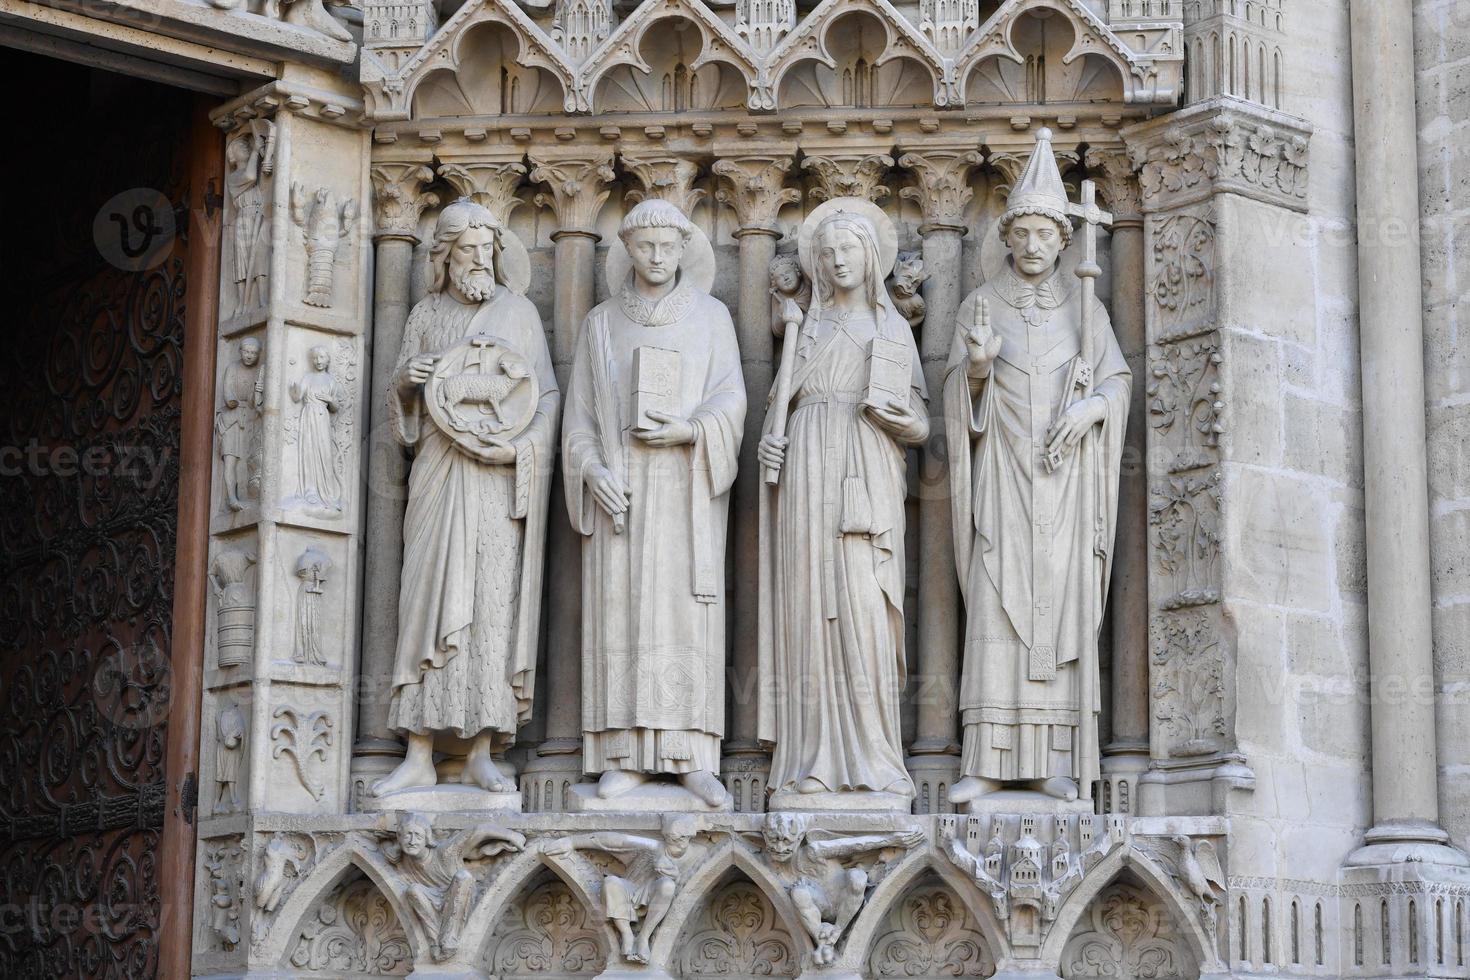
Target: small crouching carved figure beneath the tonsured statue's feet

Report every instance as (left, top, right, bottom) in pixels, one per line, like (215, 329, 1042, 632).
(545, 814, 704, 962)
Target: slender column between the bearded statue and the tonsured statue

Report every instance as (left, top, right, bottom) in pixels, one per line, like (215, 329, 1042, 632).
(522, 150, 614, 810)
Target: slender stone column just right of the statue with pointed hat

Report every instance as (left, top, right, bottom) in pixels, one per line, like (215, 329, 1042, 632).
(1086, 148, 1148, 814)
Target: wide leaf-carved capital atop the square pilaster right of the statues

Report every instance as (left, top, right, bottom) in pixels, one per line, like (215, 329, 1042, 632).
(1123, 100, 1311, 212)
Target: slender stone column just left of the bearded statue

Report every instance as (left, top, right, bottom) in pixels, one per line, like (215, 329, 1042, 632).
(351, 160, 438, 802)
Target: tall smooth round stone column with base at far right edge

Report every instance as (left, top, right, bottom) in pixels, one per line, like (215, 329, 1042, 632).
(1348, 0, 1467, 863)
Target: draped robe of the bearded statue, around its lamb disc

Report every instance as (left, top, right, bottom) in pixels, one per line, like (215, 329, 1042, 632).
(388, 287, 560, 745)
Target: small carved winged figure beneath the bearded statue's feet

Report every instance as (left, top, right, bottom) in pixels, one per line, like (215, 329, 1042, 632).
(379, 813, 526, 962)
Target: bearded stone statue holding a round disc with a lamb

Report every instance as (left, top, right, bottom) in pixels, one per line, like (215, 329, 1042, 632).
(373, 200, 560, 795)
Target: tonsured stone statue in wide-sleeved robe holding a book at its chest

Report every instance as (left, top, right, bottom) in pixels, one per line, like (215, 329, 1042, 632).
(562, 200, 745, 807)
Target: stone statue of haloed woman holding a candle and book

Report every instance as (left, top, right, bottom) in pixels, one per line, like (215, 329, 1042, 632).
(759, 198, 929, 811)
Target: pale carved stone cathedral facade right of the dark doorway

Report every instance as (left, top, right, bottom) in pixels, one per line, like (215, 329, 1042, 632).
(8, 0, 1470, 980)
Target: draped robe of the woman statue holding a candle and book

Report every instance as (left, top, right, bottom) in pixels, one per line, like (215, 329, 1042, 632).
(760, 304, 928, 795)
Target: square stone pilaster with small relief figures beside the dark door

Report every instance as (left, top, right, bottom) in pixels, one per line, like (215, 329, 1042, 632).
(193, 82, 372, 976)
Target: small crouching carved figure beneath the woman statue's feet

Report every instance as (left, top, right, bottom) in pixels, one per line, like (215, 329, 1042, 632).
(760, 813, 925, 967)
